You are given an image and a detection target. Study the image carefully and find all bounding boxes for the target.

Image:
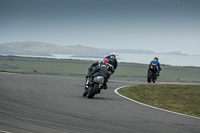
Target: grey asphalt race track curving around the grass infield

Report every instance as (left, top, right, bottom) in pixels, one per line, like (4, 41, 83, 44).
(0, 73, 200, 133)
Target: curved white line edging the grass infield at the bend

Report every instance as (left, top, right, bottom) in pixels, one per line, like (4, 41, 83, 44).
(115, 86, 200, 119)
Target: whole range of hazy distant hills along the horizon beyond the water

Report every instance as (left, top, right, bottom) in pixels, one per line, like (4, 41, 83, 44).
(0, 41, 186, 57)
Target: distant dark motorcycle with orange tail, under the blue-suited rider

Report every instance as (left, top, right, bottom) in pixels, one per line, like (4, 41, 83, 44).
(147, 66, 157, 83)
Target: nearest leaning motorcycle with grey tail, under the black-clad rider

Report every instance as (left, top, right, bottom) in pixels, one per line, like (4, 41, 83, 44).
(83, 76, 105, 99)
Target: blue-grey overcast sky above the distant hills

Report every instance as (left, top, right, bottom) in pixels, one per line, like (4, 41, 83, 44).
(0, 0, 200, 55)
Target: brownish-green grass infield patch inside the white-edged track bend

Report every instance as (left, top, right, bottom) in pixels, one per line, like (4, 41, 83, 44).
(119, 84, 200, 117)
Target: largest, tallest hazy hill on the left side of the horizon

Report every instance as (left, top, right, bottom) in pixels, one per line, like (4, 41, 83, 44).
(0, 41, 101, 55)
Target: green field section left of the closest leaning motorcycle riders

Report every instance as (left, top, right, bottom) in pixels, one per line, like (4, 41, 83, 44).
(0, 56, 92, 77)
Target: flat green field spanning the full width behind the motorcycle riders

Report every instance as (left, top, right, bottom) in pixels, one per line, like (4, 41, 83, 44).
(0, 56, 200, 83)
